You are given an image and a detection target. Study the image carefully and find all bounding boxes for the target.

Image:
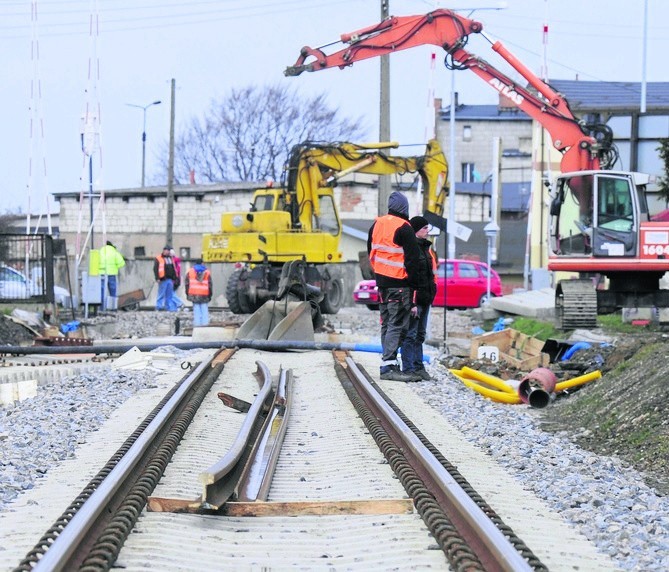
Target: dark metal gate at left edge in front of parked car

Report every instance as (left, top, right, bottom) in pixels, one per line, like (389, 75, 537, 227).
(0, 234, 54, 303)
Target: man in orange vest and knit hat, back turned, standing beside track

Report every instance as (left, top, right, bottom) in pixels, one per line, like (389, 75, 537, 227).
(367, 191, 421, 382)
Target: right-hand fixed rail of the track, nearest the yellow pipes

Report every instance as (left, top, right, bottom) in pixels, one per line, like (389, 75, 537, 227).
(346, 357, 532, 572)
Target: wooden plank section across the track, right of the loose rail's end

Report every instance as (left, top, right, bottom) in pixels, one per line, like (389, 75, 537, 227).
(222, 499, 414, 516)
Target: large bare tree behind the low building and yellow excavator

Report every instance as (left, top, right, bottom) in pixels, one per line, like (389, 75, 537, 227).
(154, 84, 365, 184)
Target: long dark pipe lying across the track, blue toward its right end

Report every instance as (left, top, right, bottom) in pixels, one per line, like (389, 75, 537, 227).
(0, 340, 382, 355)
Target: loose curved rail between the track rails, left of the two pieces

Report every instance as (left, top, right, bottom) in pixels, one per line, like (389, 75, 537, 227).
(200, 361, 274, 510)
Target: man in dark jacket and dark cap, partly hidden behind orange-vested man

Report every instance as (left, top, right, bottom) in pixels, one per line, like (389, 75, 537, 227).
(401, 216, 437, 380)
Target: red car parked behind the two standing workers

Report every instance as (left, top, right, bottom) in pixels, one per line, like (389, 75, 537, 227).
(353, 259, 502, 310)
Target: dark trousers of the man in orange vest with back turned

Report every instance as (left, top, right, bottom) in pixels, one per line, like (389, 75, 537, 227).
(379, 287, 411, 373)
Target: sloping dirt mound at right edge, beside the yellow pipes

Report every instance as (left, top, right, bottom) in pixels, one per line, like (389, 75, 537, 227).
(541, 334, 669, 494)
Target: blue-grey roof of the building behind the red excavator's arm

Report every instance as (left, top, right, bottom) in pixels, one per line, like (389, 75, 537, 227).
(549, 79, 669, 112)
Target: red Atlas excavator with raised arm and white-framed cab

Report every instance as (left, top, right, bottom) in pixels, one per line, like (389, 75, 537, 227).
(285, 9, 669, 329)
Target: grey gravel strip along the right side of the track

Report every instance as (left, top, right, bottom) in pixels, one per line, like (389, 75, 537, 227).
(415, 365, 669, 571)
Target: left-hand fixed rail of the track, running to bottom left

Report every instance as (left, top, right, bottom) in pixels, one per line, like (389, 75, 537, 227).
(33, 357, 213, 572)
